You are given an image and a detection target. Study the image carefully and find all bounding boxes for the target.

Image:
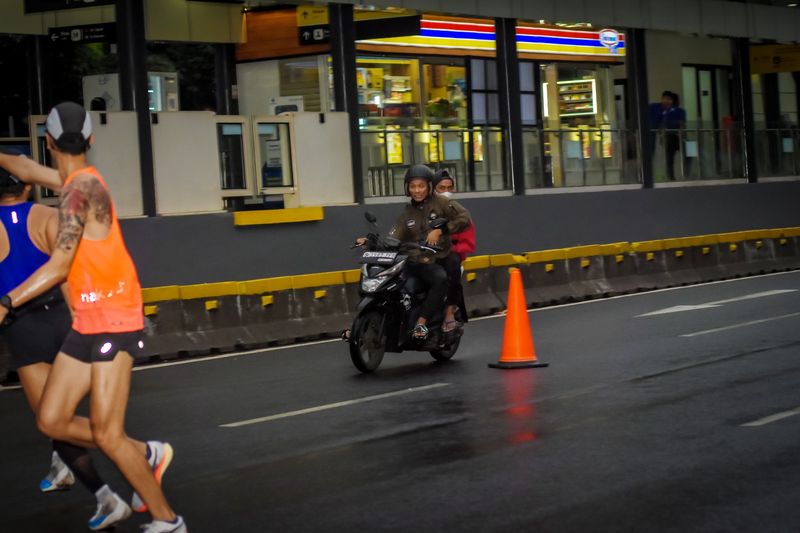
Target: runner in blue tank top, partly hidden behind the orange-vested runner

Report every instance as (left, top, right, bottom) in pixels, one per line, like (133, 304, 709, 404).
(0, 164, 130, 529)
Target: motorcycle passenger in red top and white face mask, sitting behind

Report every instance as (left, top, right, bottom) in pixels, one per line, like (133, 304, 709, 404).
(433, 169, 475, 332)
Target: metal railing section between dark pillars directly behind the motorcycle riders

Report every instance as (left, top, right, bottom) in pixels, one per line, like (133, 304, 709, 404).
(361, 127, 510, 197)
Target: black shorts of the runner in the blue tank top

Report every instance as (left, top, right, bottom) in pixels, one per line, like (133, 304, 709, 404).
(2, 293, 72, 370)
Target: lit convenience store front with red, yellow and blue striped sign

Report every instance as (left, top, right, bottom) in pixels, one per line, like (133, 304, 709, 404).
(238, 9, 638, 197)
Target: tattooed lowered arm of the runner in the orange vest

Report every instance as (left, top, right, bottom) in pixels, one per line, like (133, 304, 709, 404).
(0, 176, 90, 320)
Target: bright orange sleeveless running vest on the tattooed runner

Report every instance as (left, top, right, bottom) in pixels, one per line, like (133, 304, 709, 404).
(64, 167, 144, 335)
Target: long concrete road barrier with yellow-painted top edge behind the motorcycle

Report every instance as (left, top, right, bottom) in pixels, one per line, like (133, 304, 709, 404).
(0, 227, 800, 380)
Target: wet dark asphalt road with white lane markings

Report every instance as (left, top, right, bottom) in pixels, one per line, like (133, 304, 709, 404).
(0, 272, 800, 533)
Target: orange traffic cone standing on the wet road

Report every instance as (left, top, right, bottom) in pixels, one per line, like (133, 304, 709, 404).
(489, 268, 548, 368)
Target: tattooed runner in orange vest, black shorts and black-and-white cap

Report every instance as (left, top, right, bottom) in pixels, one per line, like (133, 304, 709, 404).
(0, 102, 187, 533)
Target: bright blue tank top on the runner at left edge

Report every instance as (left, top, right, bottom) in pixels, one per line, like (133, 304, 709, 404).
(0, 202, 50, 296)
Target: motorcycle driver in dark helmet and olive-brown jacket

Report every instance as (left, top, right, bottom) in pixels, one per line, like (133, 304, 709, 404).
(390, 165, 470, 340)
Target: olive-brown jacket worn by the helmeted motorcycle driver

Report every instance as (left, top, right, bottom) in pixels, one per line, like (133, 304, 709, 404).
(389, 194, 470, 263)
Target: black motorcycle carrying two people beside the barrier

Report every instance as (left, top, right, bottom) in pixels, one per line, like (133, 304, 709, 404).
(345, 213, 463, 373)
